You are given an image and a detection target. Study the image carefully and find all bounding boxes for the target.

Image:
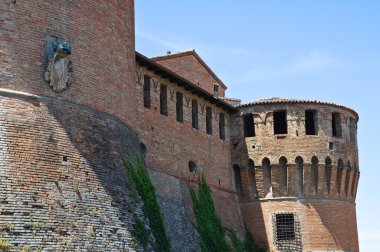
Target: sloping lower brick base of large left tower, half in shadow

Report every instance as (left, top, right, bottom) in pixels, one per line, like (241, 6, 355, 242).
(0, 92, 142, 251)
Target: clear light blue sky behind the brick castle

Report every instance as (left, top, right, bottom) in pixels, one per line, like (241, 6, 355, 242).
(135, 0, 380, 252)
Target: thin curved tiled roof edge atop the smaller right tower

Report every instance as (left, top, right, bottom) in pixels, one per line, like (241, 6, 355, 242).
(236, 97, 359, 121)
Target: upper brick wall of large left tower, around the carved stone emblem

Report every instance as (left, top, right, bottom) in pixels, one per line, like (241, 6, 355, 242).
(0, 0, 135, 125)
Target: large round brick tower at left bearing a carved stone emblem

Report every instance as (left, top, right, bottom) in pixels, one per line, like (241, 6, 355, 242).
(0, 0, 140, 251)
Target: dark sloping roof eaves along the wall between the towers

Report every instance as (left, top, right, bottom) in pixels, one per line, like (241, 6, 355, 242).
(136, 52, 238, 112)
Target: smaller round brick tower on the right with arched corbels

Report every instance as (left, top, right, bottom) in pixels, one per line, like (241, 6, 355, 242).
(232, 98, 359, 251)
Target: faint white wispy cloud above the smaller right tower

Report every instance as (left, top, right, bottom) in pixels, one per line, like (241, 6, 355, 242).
(243, 48, 338, 81)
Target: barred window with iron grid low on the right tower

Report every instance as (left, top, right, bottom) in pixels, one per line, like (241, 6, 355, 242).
(276, 214, 296, 241)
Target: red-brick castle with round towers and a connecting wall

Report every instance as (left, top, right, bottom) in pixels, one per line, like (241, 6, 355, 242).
(0, 0, 359, 252)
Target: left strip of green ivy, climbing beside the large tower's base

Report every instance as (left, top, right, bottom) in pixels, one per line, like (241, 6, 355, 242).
(123, 158, 170, 252)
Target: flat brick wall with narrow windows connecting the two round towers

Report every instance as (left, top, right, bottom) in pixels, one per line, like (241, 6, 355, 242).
(136, 63, 244, 248)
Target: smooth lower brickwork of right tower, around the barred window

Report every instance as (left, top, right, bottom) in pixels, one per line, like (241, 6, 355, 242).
(241, 199, 359, 251)
